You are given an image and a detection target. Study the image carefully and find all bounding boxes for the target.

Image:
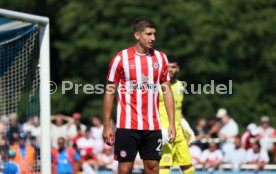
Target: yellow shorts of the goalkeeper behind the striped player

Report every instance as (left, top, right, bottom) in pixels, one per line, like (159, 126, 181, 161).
(159, 139, 192, 167)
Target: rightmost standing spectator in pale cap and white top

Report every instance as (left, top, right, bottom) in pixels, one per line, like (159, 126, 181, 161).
(256, 116, 274, 152)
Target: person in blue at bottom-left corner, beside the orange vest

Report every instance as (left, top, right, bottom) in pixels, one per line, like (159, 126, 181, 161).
(3, 149, 20, 174)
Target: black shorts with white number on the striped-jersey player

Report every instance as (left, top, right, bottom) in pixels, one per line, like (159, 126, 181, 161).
(114, 129, 162, 162)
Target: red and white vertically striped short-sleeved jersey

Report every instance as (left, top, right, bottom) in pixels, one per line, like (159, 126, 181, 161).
(107, 47, 170, 130)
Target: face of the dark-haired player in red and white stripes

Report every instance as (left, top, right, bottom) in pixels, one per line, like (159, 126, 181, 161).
(135, 28, 156, 49)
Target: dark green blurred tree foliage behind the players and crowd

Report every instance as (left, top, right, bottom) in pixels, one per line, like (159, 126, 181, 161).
(0, 0, 276, 130)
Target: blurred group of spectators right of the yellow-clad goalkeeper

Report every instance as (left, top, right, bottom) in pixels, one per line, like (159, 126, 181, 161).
(190, 108, 276, 171)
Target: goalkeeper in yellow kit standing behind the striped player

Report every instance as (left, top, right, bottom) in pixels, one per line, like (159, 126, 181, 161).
(159, 56, 195, 174)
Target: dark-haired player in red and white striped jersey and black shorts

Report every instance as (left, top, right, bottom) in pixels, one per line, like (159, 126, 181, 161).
(103, 18, 175, 174)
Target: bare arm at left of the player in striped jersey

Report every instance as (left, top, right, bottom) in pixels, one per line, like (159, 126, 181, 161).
(103, 82, 118, 145)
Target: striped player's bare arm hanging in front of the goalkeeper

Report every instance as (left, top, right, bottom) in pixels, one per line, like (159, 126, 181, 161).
(161, 81, 176, 143)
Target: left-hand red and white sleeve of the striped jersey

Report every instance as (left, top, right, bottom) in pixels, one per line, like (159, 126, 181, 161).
(106, 54, 123, 83)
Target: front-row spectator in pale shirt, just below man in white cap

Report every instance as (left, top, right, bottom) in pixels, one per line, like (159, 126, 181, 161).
(224, 136, 246, 170)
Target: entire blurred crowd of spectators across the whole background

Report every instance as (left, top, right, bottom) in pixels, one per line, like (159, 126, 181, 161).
(0, 108, 276, 174)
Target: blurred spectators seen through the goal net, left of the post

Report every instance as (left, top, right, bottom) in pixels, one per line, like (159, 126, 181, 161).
(0, 113, 41, 174)
